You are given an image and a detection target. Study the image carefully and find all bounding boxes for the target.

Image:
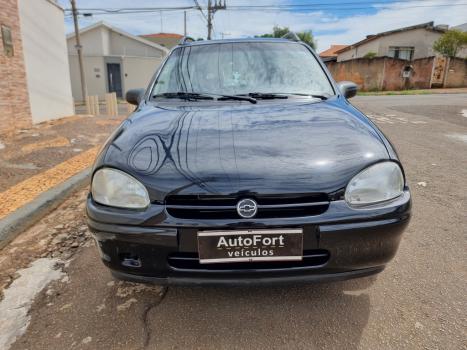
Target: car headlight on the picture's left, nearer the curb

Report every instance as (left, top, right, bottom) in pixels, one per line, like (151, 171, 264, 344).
(91, 168, 150, 209)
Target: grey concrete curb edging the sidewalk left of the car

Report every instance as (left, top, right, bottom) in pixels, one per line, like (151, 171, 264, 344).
(0, 168, 91, 249)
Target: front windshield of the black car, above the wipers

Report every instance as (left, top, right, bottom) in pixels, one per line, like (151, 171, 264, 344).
(152, 42, 334, 96)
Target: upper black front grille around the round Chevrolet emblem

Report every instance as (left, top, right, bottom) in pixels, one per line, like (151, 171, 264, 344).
(165, 193, 329, 220)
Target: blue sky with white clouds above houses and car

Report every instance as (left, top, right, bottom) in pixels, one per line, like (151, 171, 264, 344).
(58, 0, 467, 51)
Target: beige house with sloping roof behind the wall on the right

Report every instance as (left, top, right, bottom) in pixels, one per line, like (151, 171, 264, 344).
(337, 22, 458, 62)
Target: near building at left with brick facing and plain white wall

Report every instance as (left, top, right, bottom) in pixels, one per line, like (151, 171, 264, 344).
(0, 0, 74, 133)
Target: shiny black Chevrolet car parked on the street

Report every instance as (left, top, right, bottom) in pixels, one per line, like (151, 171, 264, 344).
(87, 39, 411, 284)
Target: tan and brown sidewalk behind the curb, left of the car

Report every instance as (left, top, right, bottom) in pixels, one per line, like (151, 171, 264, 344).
(0, 116, 124, 220)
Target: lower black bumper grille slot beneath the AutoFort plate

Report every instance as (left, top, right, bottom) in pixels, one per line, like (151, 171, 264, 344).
(167, 249, 329, 271)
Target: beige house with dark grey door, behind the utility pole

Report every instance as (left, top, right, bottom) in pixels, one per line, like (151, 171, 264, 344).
(67, 22, 169, 100)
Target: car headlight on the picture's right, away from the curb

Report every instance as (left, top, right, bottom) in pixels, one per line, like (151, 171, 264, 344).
(345, 162, 404, 206)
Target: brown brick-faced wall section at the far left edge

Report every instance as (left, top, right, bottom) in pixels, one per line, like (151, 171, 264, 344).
(0, 0, 32, 134)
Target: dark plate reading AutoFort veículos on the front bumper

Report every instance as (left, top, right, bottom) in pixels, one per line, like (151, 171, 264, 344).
(198, 229, 303, 264)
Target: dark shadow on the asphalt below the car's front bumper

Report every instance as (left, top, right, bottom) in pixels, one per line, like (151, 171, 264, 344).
(147, 276, 376, 349)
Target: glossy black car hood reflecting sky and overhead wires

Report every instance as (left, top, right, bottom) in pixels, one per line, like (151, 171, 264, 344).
(103, 101, 388, 201)
